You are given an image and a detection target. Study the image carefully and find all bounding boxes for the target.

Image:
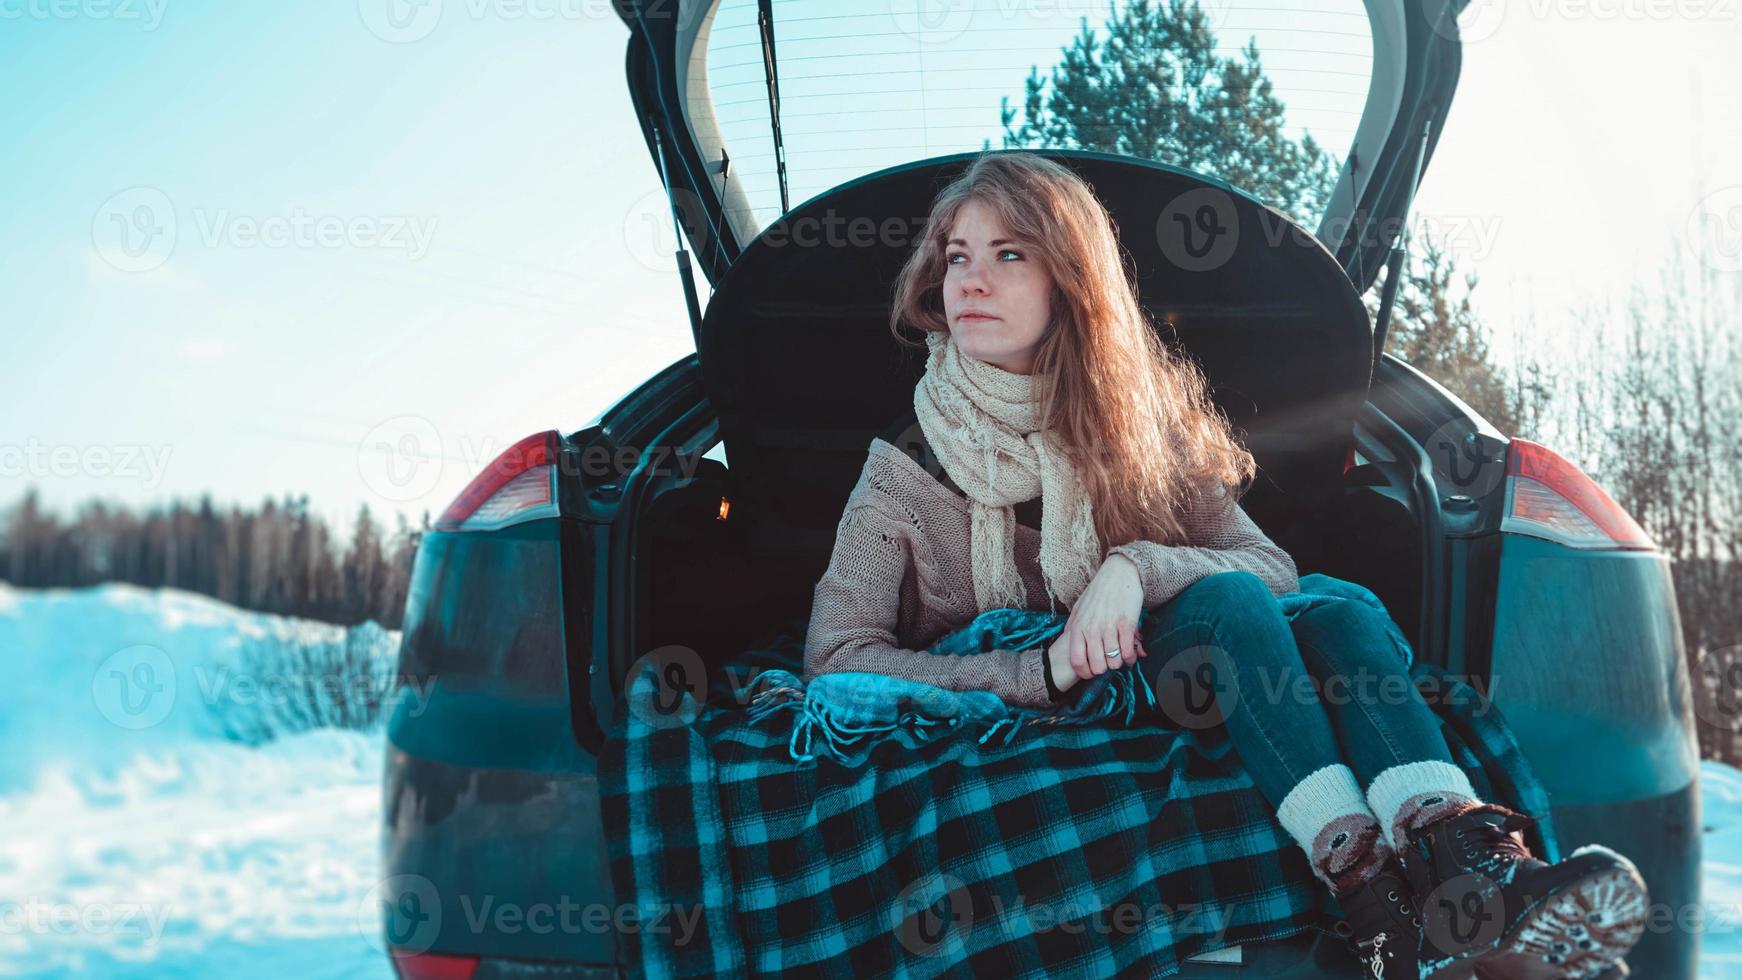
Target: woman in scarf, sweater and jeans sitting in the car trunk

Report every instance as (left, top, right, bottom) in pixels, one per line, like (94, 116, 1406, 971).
(805, 151, 1644, 980)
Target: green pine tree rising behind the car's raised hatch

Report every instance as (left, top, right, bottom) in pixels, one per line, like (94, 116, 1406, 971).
(1000, 0, 1540, 432)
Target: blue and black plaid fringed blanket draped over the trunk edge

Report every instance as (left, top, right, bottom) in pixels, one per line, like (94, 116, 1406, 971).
(599, 573, 1559, 978)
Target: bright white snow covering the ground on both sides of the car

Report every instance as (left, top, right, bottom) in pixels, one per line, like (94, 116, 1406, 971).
(0, 583, 1742, 980)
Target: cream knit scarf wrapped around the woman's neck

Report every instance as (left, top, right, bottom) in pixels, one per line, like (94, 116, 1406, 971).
(913, 331, 1103, 613)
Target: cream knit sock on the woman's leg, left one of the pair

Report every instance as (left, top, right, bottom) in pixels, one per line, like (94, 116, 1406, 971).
(1277, 762, 1392, 898)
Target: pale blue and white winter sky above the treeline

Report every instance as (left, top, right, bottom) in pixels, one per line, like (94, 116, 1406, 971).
(0, 0, 1742, 529)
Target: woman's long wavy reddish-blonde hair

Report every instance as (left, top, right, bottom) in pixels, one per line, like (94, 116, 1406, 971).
(888, 150, 1258, 548)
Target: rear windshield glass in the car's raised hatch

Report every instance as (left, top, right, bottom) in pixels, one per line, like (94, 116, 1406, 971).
(707, 0, 1373, 238)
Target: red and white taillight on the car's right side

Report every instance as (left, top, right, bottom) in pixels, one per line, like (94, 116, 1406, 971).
(1500, 439, 1657, 550)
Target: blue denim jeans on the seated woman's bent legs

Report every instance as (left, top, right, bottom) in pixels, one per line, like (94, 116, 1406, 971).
(1120, 571, 1453, 806)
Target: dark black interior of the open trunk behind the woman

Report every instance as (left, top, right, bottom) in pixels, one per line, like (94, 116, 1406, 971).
(631, 151, 1421, 685)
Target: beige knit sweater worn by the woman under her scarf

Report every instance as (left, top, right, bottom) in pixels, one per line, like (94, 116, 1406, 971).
(805, 439, 1300, 708)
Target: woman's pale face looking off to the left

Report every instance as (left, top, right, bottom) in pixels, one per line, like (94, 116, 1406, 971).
(944, 200, 1052, 374)
